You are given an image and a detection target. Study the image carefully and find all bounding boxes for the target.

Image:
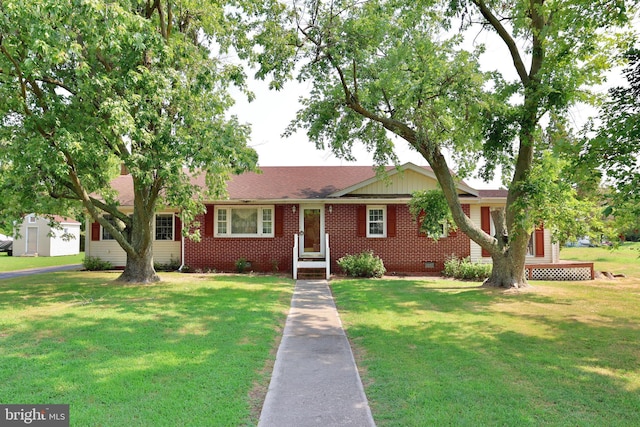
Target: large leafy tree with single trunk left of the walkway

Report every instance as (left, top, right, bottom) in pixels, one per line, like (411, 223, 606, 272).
(0, 0, 289, 282)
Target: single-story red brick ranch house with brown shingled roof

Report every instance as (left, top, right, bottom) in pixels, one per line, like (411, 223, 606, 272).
(81, 163, 593, 279)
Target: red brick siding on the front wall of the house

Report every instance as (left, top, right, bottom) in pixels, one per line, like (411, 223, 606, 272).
(185, 204, 470, 273)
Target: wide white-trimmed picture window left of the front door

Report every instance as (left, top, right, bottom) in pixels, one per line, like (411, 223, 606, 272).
(215, 206, 274, 237)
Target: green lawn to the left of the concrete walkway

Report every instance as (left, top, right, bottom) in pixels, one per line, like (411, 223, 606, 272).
(0, 272, 293, 426)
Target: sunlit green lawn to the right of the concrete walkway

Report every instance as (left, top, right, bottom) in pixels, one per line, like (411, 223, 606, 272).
(331, 248, 640, 426)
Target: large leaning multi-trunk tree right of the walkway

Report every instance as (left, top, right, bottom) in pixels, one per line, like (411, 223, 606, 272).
(289, 0, 630, 287)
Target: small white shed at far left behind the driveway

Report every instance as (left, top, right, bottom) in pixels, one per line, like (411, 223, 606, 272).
(13, 214, 80, 256)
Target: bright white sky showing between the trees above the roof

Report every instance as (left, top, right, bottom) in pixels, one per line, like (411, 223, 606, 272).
(231, 14, 640, 188)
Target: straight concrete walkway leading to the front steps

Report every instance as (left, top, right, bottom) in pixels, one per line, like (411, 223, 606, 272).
(258, 280, 375, 427)
